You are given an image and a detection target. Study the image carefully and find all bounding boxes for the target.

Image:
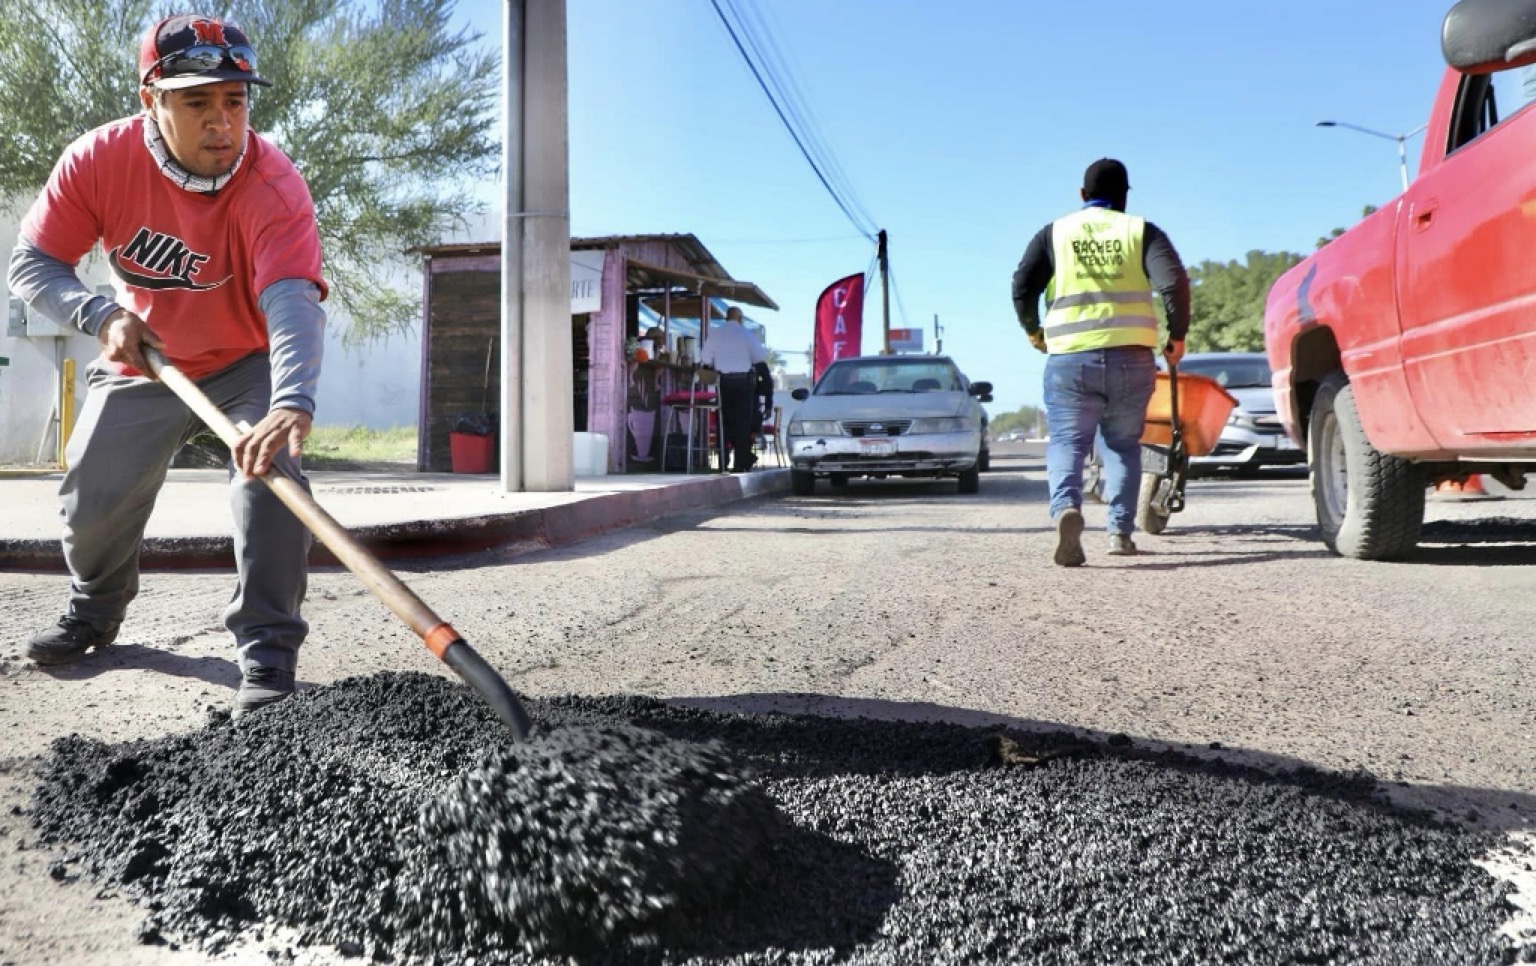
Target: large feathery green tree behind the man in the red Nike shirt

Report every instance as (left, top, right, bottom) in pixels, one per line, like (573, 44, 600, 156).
(0, 0, 499, 342)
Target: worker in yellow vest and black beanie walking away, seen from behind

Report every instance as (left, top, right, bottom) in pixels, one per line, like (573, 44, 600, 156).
(1014, 158, 1189, 567)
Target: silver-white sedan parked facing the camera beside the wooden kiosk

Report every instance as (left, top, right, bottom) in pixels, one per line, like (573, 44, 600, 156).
(786, 355, 992, 496)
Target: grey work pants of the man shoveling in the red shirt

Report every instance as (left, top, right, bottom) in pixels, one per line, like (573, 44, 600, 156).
(58, 353, 310, 671)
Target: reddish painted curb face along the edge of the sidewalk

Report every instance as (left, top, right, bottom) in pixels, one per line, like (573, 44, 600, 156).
(0, 470, 790, 573)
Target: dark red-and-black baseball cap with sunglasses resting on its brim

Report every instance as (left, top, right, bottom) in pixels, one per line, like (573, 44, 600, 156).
(138, 14, 272, 91)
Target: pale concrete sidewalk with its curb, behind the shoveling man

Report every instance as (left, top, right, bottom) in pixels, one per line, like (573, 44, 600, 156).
(0, 468, 790, 571)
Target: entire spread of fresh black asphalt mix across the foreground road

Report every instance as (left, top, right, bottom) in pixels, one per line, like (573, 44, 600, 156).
(32, 674, 1527, 966)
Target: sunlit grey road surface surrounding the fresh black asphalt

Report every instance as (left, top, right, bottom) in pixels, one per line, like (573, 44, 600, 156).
(0, 447, 1536, 966)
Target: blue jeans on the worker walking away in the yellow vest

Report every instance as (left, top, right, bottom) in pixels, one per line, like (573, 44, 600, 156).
(1046, 346, 1157, 534)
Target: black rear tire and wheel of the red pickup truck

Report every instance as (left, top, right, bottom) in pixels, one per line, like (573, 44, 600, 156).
(1307, 372, 1425, 561)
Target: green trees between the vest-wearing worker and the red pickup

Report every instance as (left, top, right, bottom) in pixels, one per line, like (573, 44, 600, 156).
(1184, 252, 1301, 352)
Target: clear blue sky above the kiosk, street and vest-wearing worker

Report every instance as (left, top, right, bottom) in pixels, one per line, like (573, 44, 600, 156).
(458, 0, 1450, 415)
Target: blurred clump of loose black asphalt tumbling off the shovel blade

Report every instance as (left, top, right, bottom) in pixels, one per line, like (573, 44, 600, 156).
(398, 725, 773, 954)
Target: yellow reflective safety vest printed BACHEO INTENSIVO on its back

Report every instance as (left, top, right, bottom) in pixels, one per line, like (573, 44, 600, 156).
(1043, 207, 1157, 353)
